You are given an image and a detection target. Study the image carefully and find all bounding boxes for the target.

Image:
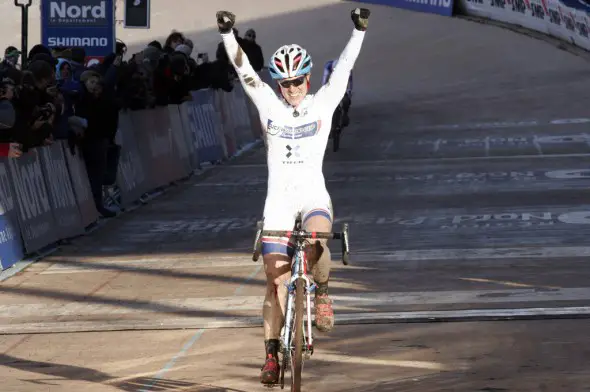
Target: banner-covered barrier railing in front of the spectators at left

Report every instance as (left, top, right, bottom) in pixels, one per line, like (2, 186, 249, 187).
(0, 72, 265, 270)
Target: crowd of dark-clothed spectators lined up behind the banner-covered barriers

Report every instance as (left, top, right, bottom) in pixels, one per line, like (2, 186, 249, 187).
(0, 29, 263, 217)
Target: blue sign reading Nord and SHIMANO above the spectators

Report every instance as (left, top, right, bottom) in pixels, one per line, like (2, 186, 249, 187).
(41, 0, 116, 59)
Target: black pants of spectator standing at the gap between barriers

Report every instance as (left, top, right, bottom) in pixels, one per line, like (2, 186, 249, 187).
(82, 139, 109, 211)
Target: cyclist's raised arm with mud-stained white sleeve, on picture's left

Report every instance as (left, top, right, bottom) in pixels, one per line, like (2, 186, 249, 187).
(217, 11, 277, 111)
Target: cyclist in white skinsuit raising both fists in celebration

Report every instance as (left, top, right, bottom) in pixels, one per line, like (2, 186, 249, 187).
(216, 8, 370, 384)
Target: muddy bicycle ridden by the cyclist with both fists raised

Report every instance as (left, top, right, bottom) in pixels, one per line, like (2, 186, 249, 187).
(252, 214, 350, 392)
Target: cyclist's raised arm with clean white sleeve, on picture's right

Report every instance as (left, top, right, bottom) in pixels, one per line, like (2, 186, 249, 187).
(316, 8, 370, 108)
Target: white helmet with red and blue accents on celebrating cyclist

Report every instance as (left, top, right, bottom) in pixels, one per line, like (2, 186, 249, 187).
(268, 44, 313, 79)
